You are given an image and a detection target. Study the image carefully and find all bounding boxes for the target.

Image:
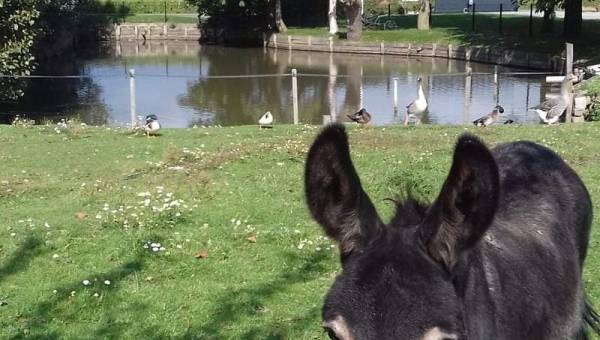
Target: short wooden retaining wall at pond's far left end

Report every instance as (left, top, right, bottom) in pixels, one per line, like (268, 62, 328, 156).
(111, 24, 201, 41)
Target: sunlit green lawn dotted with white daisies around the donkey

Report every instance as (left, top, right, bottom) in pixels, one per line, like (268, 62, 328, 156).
(0, 123, 600, 339)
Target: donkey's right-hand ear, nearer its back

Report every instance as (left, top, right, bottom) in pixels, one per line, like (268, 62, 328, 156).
(421, 135, 499, 271)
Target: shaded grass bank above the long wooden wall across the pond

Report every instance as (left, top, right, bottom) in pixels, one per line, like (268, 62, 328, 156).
(288, 14, 600, 62)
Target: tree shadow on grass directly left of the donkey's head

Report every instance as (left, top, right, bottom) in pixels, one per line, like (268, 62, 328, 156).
(183, 252, 329, 339)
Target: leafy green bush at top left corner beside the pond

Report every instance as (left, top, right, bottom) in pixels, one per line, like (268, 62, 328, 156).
(0, 0, 41, 100)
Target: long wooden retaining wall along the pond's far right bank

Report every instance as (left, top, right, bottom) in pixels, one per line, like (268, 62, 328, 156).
(263, 34, 565, 72)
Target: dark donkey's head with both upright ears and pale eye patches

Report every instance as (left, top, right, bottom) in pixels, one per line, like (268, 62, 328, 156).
(305, 125, 499, 340)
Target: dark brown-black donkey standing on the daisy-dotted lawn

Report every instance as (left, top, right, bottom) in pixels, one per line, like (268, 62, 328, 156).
(305, 125, 600, 340)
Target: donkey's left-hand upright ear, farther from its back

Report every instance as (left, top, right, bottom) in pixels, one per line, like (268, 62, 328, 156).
(304, 124, 381, 257)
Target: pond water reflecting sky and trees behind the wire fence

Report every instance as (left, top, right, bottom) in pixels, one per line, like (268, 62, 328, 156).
(0, 41, 552, 127)
